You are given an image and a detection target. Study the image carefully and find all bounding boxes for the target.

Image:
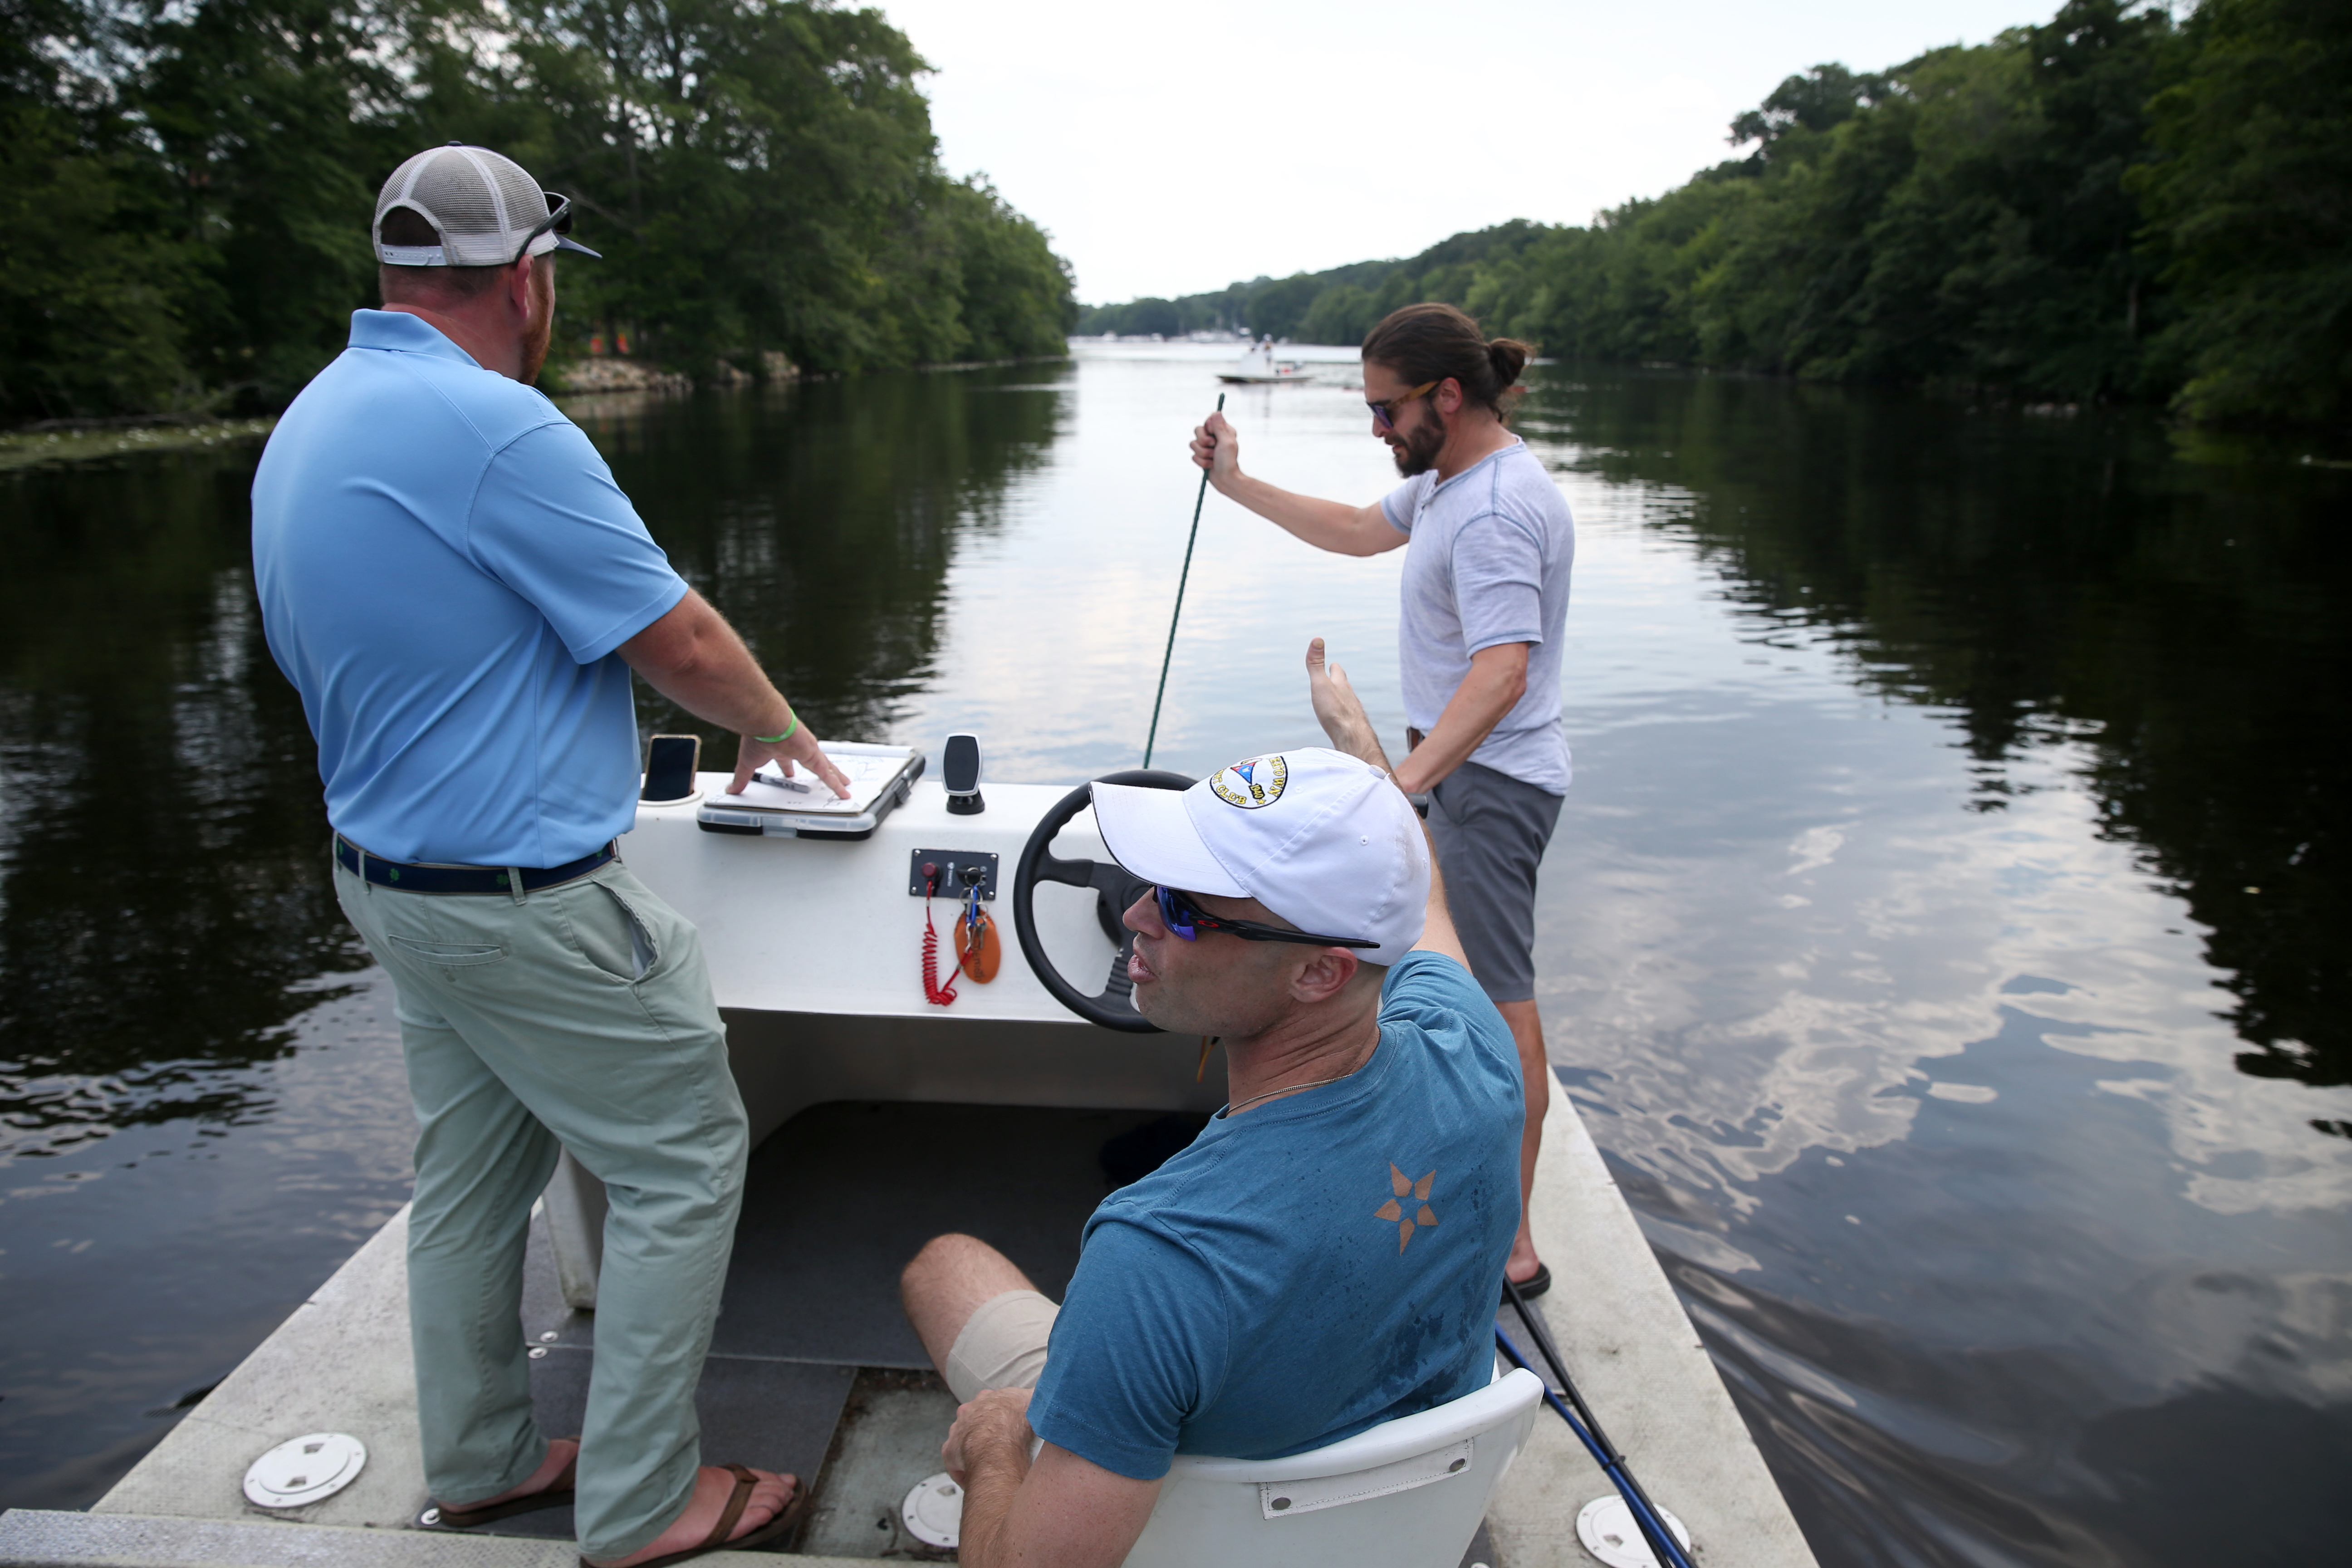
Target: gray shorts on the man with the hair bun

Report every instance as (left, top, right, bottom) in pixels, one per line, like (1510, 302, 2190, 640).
(1430, 762, 1562, 1001)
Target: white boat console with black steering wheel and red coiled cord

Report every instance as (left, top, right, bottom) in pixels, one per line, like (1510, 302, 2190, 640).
(548, 774, 1225, 1309)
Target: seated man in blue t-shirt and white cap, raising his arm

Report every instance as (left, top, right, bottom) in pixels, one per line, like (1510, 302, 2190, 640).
(903, 642, 1522, 1568)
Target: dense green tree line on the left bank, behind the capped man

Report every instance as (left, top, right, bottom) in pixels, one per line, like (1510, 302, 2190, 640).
(0, 0, 1077, 421)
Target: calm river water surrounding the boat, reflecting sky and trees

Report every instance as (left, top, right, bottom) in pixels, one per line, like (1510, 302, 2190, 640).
(0, 346, 2352, 1568)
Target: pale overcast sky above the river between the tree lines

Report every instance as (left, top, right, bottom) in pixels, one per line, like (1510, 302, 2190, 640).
(880, 0, 2058, 303)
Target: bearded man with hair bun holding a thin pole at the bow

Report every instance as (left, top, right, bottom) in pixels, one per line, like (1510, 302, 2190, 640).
(1192, 303, 1576, 1295)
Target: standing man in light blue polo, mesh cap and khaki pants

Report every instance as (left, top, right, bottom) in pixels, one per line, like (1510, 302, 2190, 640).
(254, 143, 849, 1566)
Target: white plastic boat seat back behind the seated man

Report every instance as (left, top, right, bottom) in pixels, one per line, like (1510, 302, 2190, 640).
(1127, 1368, 1543, 1568)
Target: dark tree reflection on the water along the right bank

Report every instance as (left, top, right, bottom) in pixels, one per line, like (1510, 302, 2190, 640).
(1529, 374, 2352, 1091)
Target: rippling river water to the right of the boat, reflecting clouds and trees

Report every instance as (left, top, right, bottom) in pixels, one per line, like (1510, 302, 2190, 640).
(1529, 372, 2352, 1563)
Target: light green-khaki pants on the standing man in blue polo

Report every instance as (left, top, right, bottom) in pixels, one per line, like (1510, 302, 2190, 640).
(334, 860, 748, 1556)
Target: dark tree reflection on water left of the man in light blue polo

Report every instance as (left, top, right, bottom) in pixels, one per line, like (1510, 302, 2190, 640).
(0, 451, 367, 1154)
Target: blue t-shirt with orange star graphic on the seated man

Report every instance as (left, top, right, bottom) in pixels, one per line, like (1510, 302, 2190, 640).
(1030, 952, 1522, 1481)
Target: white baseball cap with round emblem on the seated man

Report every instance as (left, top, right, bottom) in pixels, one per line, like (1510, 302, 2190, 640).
(1094, 745, 1430, 964)
